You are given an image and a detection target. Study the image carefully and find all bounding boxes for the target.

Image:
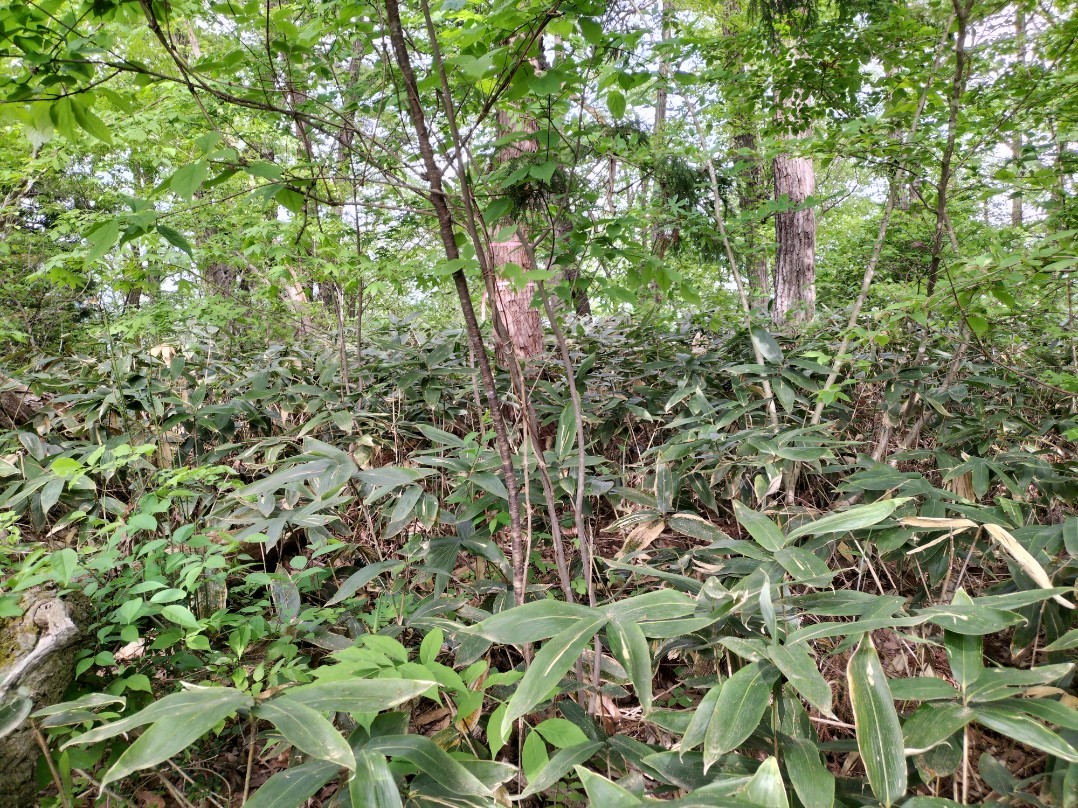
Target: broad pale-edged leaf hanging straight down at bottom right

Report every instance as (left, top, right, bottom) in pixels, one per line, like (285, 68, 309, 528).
(846, 636, 907, 806)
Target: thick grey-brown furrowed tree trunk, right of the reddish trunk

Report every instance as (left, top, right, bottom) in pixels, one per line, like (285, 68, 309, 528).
(773, 112, 816, 324)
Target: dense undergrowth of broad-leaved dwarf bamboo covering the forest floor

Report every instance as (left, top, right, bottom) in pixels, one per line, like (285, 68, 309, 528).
(0, 319, 1078, 808)
